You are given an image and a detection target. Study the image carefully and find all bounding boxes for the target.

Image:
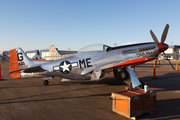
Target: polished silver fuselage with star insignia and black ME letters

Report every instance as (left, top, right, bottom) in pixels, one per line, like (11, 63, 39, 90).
(21, 42, 159, 80)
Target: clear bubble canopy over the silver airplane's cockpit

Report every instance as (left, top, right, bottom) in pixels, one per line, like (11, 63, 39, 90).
(78, 44, 110, 53)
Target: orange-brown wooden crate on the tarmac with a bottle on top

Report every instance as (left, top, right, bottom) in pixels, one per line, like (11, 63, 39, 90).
(111, 89, 156, 118)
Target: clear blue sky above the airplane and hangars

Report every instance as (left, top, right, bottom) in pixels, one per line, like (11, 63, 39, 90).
(0, 0, 180, 51)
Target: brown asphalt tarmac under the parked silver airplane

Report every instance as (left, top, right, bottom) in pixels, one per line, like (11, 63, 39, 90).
(0, 62, 180, 120)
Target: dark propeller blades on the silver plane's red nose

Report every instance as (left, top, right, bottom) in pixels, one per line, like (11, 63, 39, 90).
(150, 24, 175, 70)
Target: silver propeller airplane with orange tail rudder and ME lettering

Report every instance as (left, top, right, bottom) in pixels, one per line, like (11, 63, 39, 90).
(9, 24, 172, 88)
